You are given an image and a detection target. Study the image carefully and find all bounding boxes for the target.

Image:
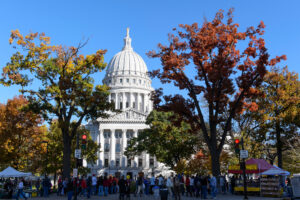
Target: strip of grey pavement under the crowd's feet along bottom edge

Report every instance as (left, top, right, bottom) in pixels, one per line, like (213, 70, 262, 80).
(6, 194, 282, 200)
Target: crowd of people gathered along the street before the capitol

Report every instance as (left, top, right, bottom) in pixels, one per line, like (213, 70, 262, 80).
(57, 173, 228, 200)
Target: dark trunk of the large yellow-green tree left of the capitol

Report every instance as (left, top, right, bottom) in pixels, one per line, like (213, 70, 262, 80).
(63, 132, 71, 179)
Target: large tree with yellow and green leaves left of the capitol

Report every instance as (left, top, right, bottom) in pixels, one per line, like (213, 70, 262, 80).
(1, 30, 113, 177)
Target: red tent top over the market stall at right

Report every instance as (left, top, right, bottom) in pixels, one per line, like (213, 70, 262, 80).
(228, 158, 274, 174)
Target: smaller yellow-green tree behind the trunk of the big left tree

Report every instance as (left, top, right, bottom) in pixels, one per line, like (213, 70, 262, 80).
(43, 120, 100, 181)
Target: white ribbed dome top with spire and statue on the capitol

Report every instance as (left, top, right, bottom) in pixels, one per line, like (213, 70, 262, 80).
(106, 28, 148, 77)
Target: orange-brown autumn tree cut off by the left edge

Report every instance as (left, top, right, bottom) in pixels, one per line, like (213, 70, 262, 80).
(0, 96, 46, 171)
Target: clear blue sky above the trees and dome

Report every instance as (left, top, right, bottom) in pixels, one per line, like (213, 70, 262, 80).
(0, 0, 300, 103)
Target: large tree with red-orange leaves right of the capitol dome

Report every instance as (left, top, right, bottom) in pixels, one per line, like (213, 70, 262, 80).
(148, 10, 286, 176)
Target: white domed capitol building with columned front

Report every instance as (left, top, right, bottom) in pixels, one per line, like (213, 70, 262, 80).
(86, 28, 167, 176)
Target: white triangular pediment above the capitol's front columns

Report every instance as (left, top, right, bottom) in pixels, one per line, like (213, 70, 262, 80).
(97, 108, 147, 123)
